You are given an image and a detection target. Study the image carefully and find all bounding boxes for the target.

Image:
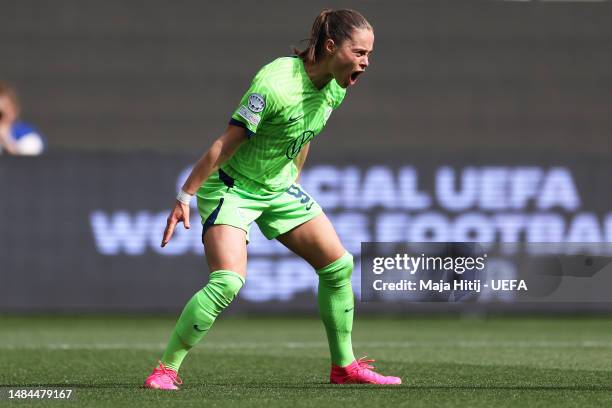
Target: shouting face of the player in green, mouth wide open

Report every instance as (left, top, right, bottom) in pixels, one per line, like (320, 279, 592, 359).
(330, 29, 374, 88)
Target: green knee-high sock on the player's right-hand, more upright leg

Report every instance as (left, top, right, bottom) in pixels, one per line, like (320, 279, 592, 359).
(317, 252, 355, 367)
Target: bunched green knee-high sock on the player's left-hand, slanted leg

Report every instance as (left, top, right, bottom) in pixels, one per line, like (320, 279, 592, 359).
(161, 270, 244, 371)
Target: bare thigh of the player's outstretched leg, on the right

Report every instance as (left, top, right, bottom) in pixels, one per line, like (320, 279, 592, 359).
(276, 213, 346, 269)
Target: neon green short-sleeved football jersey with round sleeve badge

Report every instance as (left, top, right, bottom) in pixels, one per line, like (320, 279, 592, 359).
(221, 57, 346, 192)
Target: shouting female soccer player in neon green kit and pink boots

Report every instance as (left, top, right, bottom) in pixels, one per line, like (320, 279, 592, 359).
(144, 9, 401, 390)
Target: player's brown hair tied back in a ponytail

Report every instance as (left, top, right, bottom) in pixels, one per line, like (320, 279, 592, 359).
(293, 8, 372, 63)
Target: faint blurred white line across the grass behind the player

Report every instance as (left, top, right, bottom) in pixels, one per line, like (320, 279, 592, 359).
(0, 340, 612, 351)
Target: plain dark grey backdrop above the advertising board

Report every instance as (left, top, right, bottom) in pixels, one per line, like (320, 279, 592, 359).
(0, 0, 612, 159)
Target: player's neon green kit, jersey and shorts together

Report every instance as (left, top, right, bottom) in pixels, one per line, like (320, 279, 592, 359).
(197, 57, 346, 240)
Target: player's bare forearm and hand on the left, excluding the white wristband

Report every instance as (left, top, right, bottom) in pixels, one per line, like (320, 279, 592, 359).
(161, 125, 248, 248)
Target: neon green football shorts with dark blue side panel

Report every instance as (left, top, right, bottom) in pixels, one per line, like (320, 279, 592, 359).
(197, 170, 323, 242)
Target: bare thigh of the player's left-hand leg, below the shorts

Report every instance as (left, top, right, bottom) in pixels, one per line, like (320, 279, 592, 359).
(203, 224, 247, 278)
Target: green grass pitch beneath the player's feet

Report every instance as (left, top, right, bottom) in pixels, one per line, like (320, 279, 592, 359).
(0, 316, 612, 408)
